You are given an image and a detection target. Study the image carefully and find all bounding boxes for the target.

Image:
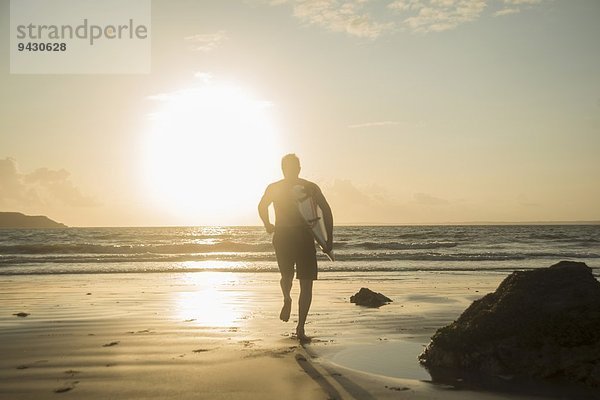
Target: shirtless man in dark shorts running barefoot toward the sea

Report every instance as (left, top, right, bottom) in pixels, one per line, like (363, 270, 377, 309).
(258, 154, 333, 341)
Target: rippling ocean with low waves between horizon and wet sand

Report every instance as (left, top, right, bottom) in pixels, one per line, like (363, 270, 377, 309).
(0, 225, 600, 276)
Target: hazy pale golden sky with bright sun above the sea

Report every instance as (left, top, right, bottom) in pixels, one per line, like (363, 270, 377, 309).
(0, 0, 600, 226)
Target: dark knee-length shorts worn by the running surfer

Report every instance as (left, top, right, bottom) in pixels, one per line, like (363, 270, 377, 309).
(273, 227, 317, 280)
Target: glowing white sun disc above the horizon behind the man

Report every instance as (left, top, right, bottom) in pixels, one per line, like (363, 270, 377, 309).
(142, 77, 281, 225)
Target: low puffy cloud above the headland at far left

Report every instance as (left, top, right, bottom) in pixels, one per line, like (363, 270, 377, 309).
(0, 158, 97, 211)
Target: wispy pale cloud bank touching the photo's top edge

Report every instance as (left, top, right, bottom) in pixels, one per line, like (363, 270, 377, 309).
(266, 0, 542, 39)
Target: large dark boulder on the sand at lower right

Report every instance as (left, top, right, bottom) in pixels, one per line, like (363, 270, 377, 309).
(419, 261, 600, 387)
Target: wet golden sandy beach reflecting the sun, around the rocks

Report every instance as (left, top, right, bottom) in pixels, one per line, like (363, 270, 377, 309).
(0, 272, 592, 399)
